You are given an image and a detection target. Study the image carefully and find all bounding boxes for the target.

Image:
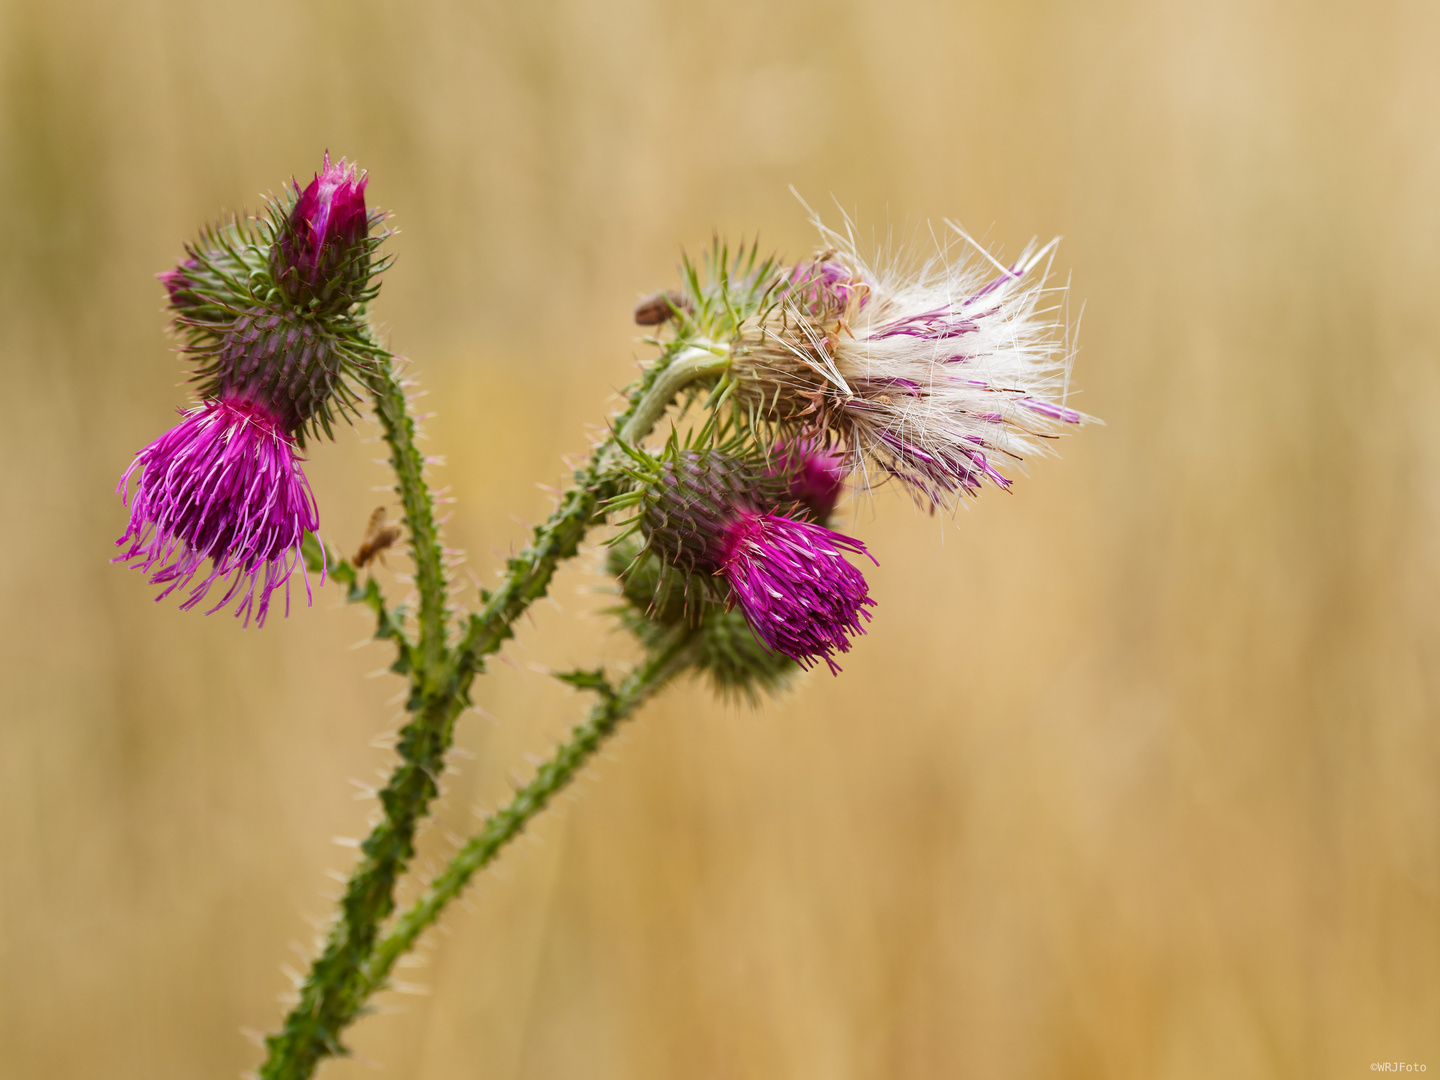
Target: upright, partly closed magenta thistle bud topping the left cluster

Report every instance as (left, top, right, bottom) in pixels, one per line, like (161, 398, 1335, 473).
(272, 153, 370, 307)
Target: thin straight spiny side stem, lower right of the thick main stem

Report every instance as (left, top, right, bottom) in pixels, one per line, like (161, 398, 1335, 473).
(364, 626, 697, 992)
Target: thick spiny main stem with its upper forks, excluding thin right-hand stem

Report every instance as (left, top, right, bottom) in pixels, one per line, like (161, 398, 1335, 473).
(258, 346, 729, 1080)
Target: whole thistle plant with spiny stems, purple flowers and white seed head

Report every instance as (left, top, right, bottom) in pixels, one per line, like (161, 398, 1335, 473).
(117, 156, 1087, 1080)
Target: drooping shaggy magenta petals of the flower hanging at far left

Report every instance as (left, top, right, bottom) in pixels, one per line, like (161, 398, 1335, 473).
(114, 397, 320, 626)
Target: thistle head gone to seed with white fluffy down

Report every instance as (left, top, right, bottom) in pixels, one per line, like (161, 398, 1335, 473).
(733, 217, 1089, 508)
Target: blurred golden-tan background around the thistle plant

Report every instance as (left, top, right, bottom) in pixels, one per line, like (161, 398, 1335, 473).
(0, 0, 1440, 1080)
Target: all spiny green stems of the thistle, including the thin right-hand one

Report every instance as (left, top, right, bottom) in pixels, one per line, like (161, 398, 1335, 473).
(258, 346, 727, 1080)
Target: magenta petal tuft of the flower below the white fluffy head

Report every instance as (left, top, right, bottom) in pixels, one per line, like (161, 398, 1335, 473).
(719, 510, 880, 674)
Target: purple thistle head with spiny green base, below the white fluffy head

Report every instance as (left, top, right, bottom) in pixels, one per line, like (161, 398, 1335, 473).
(632, 446, 874, 671)
